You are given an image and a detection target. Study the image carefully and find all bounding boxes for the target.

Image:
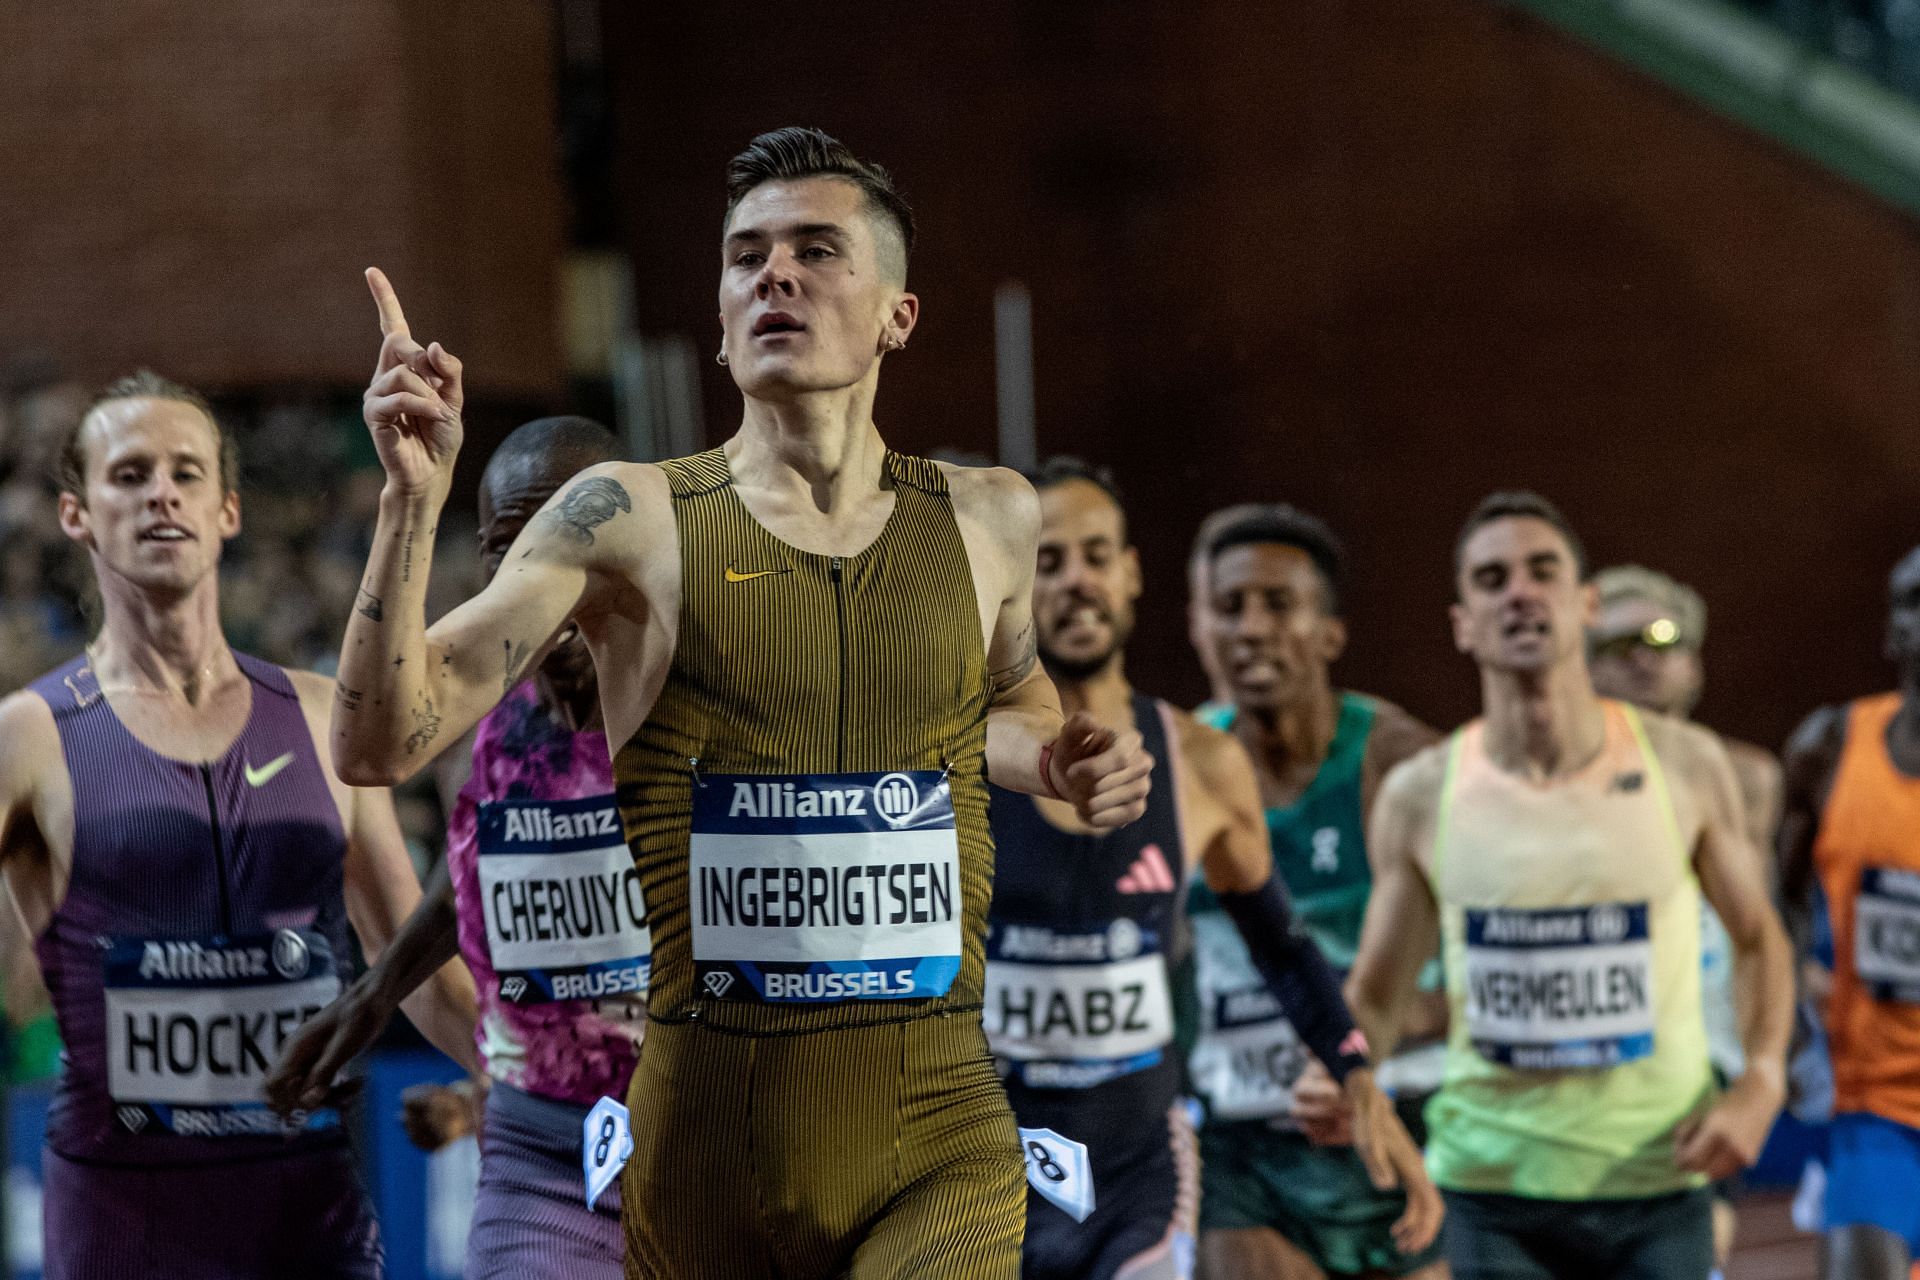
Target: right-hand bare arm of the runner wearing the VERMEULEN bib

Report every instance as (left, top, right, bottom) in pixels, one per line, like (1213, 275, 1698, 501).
(1674, 718, 1793, 1178)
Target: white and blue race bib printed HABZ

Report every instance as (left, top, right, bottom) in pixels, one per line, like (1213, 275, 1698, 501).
(981, 919, 1173, 1088)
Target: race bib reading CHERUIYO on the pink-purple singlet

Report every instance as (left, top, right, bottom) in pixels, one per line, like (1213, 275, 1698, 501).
(476, 796, 653, 1004)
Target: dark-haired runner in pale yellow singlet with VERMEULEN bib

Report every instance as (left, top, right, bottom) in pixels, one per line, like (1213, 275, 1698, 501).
(1348, 493, 1793, 1280)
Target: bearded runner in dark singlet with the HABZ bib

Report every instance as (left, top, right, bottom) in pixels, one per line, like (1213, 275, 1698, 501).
(985, 459, 1440, 1280)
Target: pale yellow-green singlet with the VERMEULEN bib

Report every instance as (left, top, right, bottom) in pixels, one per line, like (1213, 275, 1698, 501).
(1427, 702, 1713, 1199)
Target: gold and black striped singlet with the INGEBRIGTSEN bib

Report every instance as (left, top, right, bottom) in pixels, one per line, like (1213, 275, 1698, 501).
(614, 449, 993, 1034)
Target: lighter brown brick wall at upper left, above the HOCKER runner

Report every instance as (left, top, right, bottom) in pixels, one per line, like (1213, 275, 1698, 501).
(0, 0, 563, 397)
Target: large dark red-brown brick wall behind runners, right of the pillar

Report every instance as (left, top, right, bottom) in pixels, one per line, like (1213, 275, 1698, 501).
(607, 0, 1920, 741)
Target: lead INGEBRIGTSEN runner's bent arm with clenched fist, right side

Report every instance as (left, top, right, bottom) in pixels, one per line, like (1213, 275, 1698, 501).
(943, 466, 1154, 829)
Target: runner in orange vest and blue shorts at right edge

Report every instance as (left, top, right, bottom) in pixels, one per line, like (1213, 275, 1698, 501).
(1780, 549, 1920, 1280)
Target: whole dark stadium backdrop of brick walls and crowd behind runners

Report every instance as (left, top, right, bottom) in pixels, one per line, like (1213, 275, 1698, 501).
(0, 0, 1920, 1274)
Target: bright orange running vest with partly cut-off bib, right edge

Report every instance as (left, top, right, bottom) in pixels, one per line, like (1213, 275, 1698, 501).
(1812, 693, 1920, 1128)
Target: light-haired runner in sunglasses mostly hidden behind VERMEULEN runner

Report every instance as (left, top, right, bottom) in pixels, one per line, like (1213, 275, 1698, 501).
(1586, 564, 1780, 1267)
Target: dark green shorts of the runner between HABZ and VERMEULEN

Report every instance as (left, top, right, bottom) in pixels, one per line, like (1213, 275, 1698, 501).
(1200, 1103, 1440, 1276)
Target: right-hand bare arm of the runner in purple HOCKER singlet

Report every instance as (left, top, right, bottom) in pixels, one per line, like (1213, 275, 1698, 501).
(290, 672, 480, 1073)
